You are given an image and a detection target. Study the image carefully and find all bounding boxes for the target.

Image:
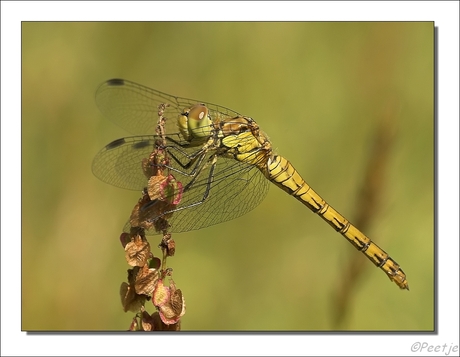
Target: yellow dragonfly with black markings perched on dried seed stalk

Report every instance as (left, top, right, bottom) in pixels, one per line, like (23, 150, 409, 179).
(92, 79, 409, 290)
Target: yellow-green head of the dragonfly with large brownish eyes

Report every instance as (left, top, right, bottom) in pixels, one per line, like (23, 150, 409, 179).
(177, 104, 212, 142)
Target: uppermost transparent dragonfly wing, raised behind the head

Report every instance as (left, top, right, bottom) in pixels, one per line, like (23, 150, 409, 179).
(96, 79, 239, 135)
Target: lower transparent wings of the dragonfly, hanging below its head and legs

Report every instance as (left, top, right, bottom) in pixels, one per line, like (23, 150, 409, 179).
(93, 135, 270, 234)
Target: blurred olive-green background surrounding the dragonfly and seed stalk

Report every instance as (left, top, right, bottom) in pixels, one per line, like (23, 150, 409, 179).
(22, 22, 434, 331)
